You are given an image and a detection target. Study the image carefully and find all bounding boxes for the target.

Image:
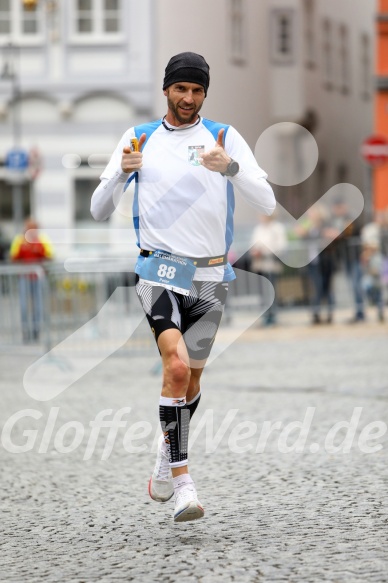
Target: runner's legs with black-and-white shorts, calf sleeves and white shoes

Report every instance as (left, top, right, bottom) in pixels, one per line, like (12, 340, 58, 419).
(136, 281, 228, 522)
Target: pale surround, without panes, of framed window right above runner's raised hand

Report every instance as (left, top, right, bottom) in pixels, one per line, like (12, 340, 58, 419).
(270, 7, 296, 65)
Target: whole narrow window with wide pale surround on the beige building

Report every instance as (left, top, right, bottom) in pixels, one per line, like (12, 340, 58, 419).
(270, 8, 295, 65)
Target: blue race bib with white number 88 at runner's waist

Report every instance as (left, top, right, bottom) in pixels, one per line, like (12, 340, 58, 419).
(139, 250, 196, 296)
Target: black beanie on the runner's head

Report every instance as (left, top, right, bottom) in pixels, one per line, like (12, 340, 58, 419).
(163, 53, 210, 96)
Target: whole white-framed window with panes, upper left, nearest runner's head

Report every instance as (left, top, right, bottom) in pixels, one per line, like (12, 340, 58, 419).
(74, 0, 121, 38)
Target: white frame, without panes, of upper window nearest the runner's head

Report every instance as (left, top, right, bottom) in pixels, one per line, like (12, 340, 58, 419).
(69, 0, 123, 45)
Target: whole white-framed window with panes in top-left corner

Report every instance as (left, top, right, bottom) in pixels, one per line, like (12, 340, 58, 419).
(0, 0, 43, 42)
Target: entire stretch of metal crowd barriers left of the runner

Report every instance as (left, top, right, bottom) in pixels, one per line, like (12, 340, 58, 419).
(0, 262, 156, 354)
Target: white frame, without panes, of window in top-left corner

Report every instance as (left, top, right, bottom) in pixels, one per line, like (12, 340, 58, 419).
(0, 0, 45, 46)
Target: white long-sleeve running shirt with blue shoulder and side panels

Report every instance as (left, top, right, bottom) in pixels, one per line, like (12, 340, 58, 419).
(91, 118, 276, 281)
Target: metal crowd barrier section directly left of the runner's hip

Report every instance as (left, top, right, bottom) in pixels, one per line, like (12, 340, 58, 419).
(43, 260, 156, 354)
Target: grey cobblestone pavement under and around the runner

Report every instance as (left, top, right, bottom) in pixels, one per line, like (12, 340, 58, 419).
(0, 308, 388, 583)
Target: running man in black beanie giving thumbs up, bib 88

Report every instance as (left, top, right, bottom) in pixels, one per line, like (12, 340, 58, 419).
(91, 52, 276, 522)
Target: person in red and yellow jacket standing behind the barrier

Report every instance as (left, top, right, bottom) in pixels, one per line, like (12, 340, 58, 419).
(10, 218, 54, 342)
